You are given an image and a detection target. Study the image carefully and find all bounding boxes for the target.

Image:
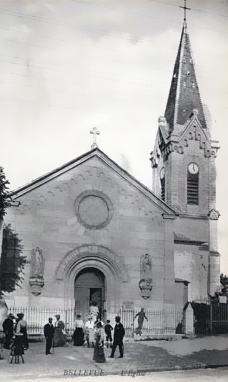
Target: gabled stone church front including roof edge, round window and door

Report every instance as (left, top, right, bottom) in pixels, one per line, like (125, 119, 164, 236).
(4, 148, 176, 314)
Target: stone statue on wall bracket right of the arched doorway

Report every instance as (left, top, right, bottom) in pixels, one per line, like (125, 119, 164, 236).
(139, 253, 153, 299)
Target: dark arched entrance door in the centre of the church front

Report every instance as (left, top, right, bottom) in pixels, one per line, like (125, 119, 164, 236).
(74, 267, 106, 322)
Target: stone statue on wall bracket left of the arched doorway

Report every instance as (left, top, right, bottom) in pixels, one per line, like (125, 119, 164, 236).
(29, 247, 44, 296)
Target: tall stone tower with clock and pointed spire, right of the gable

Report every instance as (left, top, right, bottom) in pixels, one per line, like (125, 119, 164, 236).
(151, 20, 220, 300)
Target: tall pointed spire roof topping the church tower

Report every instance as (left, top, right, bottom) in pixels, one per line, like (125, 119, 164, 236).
(165, 23, 207, 133)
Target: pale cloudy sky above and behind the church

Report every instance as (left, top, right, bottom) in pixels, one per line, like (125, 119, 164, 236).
(0, 0, 228, 274)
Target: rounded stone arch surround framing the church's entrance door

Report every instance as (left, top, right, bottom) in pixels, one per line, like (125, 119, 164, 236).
(56, 245, 129, 320)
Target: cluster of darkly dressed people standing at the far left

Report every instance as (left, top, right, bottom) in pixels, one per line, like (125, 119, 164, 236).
(2, 313, 29, 356)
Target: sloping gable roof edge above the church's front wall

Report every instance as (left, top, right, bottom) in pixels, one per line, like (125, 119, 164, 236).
(11, 148, 178, 216)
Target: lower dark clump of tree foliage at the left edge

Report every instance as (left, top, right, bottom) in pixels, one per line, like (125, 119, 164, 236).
(0, 224, 27, 294)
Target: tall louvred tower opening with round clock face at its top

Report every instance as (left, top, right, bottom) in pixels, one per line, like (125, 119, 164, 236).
(187, 162, 199, 205)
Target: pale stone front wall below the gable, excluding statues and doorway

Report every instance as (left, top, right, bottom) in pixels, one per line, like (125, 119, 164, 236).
(5, 157, 174, 316)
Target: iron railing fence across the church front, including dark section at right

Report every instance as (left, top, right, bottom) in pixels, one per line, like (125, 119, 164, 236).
(8, 300, 228, 338)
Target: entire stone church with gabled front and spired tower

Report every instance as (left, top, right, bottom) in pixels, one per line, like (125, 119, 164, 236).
(0, 21, 220, 332)
